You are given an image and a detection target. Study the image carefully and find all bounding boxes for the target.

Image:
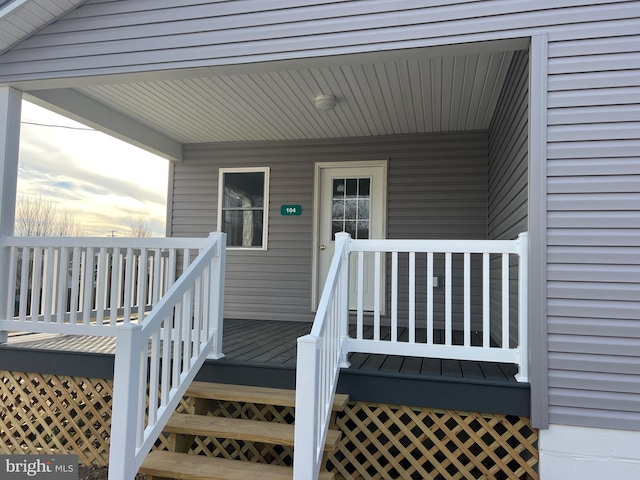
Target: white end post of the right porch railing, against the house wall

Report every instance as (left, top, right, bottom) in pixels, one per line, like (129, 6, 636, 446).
(516, 232, 529, 382)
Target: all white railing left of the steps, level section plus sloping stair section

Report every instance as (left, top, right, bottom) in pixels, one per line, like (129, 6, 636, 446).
(0, 233, 226, 480)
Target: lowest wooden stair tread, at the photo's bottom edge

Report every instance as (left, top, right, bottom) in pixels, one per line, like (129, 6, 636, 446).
(140, 450, 334, 480)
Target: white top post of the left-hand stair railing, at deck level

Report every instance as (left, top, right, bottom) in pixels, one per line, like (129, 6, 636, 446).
(207, 232, 227, 359)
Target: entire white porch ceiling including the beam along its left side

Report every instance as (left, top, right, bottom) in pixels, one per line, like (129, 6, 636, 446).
(17, 39, 528, 160)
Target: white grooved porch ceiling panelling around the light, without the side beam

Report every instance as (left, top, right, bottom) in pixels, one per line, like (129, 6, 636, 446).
(76, 52, 512, 143)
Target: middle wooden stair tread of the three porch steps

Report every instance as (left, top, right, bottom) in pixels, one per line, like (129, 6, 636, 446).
(163, 413, 342, 452)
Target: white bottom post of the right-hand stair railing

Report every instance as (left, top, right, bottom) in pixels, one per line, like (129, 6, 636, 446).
(293, 335, 321, 480)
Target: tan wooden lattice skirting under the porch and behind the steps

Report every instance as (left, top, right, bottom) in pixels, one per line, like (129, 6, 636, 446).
(0, 372, 538, 480)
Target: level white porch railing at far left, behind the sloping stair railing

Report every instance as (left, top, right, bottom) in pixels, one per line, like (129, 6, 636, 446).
(0, 237, 207, 336)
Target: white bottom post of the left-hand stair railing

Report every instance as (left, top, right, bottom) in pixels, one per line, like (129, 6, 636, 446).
(109, 324, 143, 480)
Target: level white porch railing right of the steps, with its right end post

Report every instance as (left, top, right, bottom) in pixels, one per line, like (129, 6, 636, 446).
(347, 232, 528, 382)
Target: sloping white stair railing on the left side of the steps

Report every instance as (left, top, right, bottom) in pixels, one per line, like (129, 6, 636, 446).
(109, 233, 226, 480)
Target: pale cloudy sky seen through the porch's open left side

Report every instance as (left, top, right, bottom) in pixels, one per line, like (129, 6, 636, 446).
(18, 101, 169, 237)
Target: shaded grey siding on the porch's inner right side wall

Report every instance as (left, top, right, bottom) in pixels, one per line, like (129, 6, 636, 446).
(487, 51, 529, 346)
